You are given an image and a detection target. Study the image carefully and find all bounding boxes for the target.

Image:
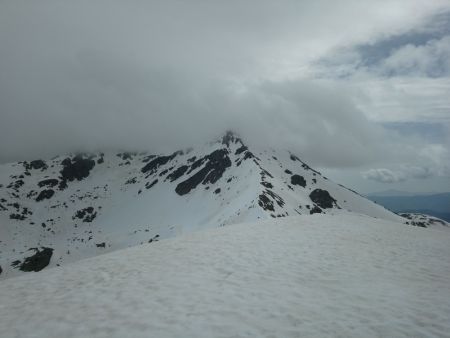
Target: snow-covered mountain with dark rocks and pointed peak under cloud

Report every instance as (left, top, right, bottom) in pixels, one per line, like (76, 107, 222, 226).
(0, 132, 405, 277)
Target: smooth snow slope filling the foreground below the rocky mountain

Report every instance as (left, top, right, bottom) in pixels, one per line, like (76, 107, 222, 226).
(0, 213, 450, 338)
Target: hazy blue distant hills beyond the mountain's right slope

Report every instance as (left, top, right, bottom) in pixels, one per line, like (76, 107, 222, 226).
(367, 193, 450, 222)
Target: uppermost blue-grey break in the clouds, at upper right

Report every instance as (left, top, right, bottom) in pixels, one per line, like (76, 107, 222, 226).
(316, 11, 450, 78)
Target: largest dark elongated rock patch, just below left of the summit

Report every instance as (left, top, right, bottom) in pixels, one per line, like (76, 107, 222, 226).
(175, 149, 231, 195)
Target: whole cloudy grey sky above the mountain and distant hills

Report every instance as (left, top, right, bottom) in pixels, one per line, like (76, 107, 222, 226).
(0, 0, 450, 193)
